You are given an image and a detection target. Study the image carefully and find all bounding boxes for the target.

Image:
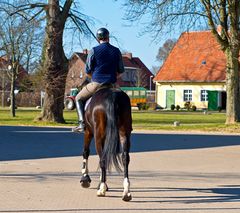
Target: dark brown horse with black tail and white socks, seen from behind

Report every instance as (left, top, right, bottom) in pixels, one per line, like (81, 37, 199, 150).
(80, 88, 132, 201)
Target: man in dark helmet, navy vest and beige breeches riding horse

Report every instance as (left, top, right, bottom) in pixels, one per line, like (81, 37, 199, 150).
(72, 28, 124, 132)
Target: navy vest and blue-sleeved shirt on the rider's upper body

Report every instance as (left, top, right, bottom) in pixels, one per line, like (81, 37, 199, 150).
(85, 42, 124, 83)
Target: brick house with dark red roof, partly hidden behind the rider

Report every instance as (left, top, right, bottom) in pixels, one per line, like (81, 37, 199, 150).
(65, 50, 153, 94)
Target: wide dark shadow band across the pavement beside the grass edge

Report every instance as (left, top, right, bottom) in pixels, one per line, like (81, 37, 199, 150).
(0, 126, 240, 161)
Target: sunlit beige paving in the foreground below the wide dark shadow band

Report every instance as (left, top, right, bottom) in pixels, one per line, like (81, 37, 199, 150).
(0, 141, 240, 213)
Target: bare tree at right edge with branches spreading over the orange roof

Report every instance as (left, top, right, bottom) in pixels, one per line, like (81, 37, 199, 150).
(125, 0, 240, 124)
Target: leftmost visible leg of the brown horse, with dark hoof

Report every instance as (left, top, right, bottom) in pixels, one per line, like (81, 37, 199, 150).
(80, 128, 93, 188)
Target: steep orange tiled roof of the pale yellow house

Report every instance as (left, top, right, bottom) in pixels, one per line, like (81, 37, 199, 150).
(154, 31, 226, 82)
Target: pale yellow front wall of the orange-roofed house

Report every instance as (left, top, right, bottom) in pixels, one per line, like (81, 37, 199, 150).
(156, 83, 226, 108)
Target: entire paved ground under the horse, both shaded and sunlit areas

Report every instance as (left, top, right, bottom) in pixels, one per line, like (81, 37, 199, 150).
(0, 127, 240, 213)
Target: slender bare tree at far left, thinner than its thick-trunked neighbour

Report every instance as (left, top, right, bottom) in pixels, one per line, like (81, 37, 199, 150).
(0, 1, 40, 117)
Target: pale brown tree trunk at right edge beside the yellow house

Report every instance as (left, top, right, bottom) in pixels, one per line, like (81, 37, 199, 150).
(225, 47, 240, 124)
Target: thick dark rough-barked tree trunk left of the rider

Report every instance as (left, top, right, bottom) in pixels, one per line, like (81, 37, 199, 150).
(39, 0, 68, 123)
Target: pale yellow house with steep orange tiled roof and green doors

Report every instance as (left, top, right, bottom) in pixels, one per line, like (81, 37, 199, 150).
(154, 31, 226, 109)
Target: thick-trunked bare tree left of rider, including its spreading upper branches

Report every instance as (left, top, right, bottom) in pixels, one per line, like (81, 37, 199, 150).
(1, 0, 95, 123)
